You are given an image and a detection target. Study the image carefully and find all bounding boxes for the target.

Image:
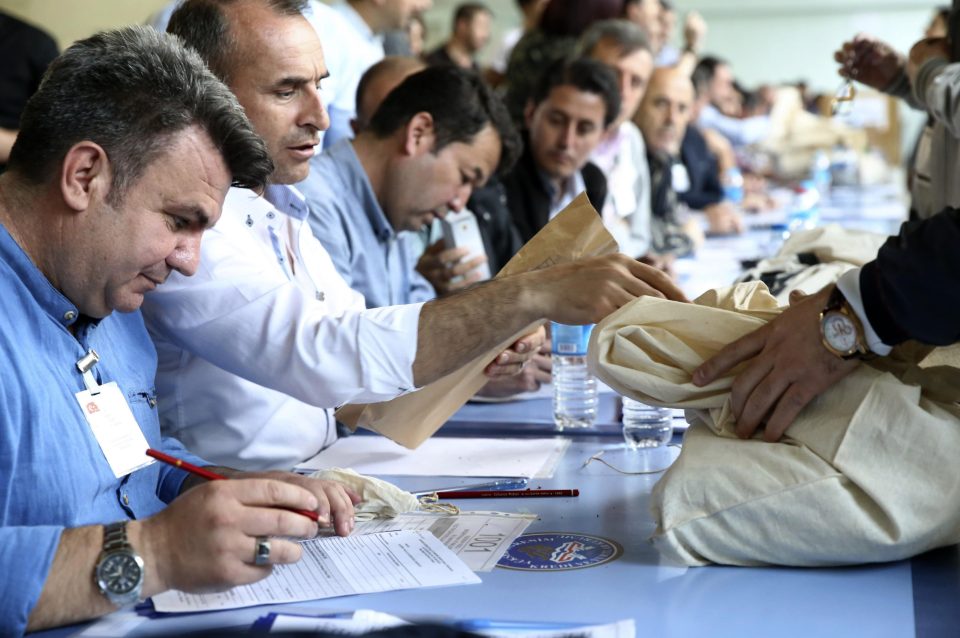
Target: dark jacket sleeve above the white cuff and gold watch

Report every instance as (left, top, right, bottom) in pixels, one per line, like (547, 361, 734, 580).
(860, 208, 960, 345)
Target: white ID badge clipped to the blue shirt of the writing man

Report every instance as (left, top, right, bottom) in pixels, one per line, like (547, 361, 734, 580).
(75, 381, 154, 478)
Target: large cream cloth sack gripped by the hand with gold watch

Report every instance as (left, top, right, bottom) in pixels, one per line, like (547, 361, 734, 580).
(589, 283, 960, 566)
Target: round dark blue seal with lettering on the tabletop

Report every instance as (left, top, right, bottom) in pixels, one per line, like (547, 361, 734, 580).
(497, 532, 623, 572)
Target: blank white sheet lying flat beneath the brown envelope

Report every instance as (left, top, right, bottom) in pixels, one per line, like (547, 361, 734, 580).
(297, 436, 570, 478)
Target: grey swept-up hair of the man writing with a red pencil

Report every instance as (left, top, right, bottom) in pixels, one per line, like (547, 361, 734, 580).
(7, 26, 273, 205)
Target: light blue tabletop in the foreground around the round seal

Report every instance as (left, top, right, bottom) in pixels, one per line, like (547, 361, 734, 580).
(48, 432, 960, 638)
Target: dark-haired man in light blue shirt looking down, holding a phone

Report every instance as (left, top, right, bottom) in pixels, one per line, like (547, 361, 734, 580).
(300, 65, 510, 308)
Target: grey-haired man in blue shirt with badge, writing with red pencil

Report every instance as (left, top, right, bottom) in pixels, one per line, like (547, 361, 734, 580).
(0, 27, 353, 636)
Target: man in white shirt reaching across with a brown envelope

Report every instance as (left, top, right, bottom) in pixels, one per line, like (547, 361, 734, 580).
(144, 0, 682, 469)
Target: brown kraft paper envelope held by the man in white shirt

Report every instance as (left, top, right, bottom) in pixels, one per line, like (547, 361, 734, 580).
(336, 193, 618, 449)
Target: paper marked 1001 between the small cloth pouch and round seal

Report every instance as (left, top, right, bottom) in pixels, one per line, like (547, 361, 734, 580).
(353, 512, 537, 572)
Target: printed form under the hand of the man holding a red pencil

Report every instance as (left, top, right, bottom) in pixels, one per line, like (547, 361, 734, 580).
(153, 530, 480, 612)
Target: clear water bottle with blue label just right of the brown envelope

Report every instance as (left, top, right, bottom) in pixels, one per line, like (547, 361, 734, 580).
(550, 323, 597, 430)
